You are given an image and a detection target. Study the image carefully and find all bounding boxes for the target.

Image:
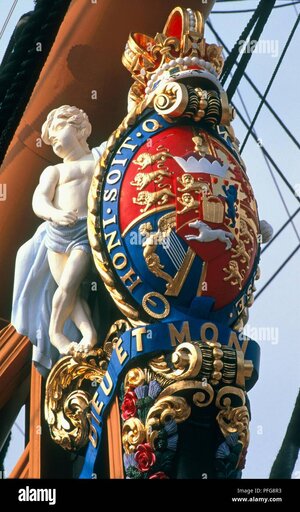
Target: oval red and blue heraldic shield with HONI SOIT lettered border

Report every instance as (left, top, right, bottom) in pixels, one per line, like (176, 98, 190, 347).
(100, 114, 258, 318)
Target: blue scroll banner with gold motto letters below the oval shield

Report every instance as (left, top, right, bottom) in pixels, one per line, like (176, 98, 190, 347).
(79, 317, 260, 478)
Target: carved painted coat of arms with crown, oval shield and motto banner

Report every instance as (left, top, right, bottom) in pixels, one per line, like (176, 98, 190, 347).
(48, 7, 260, 478)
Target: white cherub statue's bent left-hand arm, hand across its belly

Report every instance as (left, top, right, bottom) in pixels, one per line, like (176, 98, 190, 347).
(32, 166, 77, 226)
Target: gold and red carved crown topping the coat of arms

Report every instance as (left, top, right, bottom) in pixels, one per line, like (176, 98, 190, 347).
(122, 7, 224, 101)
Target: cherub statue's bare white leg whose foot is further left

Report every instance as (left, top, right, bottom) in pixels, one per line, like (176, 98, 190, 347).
(48, 250, 90, 354)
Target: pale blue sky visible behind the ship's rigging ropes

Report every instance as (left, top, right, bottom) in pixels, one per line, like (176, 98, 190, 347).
(0, 0, 300, 478)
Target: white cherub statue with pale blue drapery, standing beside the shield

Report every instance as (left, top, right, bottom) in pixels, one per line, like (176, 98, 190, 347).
(12, 105, 105, 376)
